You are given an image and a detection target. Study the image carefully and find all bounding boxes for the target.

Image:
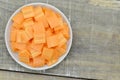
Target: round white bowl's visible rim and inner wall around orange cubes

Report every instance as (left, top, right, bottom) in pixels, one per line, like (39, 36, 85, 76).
(5, 3, 72, 70)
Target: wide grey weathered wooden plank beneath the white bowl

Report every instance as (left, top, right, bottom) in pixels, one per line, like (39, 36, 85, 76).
(0, 0, 120, 80)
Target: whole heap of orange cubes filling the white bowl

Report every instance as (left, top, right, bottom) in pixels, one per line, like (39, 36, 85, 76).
(10, 6, 70, 67)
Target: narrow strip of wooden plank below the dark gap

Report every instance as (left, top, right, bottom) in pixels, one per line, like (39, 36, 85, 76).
(0, 71, 82, 80)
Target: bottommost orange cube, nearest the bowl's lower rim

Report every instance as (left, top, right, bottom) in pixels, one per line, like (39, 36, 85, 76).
(32, 56, 45, 67)
